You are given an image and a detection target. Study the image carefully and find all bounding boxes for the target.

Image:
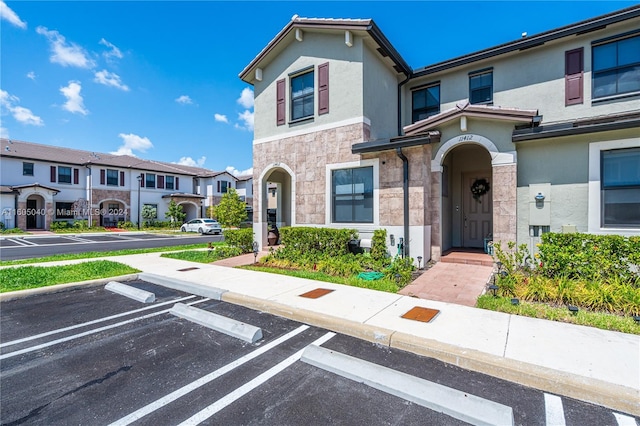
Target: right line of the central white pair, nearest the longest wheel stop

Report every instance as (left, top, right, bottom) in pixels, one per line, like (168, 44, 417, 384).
(175, 332, 336, 426)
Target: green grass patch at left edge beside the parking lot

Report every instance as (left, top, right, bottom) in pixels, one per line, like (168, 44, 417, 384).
(0, 260, 140, 293)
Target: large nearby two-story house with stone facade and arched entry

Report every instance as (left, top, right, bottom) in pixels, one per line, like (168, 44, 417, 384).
(240, 6, 640, 260)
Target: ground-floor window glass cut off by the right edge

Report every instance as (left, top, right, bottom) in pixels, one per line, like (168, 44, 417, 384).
(601, 148, 640, 228)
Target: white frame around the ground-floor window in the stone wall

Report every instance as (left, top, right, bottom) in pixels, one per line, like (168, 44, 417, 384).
(325, 158, 380, 226)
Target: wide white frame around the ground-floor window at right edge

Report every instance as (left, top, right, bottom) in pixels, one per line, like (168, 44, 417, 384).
(587, 138, 640, 236)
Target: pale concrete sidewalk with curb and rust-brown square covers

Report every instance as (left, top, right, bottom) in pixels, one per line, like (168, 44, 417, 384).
(0, 253, 640, 416)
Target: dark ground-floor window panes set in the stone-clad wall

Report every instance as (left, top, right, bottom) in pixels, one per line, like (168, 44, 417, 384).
(331, 166, 373, 223)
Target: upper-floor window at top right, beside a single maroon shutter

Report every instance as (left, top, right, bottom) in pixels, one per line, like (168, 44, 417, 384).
(593, 35, 640, 99)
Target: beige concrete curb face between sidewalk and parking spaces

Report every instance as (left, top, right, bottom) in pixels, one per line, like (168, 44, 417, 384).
(221, 292, 640, 416)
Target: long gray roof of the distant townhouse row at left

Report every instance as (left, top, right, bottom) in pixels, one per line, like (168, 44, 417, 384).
(0, 138, 222, 177)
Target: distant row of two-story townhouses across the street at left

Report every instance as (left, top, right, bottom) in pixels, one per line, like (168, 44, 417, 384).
(0, 139, 252, 230)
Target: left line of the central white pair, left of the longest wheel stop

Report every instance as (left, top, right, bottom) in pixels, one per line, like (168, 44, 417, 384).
(110, 325, 318, 426)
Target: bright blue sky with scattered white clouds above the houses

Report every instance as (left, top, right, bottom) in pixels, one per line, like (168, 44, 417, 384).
(0, 0, 637, 174)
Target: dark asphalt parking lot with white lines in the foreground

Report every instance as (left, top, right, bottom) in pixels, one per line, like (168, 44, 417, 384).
(0, 281, 637, 425)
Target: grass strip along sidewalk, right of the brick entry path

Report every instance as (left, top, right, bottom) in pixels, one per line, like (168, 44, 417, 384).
(476, 294, 640, 334)
